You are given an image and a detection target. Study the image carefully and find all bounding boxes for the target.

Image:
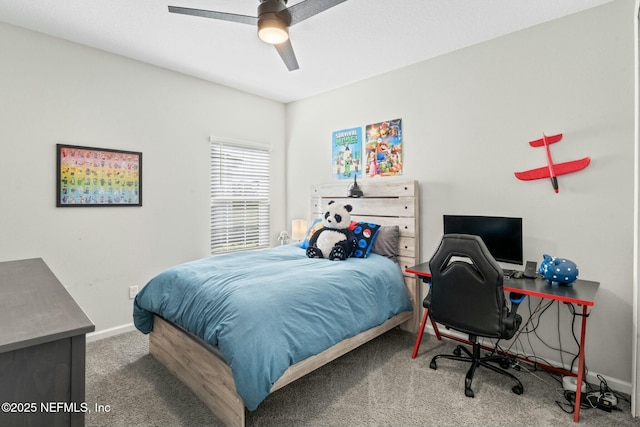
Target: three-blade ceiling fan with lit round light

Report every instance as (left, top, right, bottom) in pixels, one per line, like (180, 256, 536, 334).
(169, 0, 347, 71)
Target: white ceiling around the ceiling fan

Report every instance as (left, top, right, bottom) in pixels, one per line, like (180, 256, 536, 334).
(0, 0, 612, 102)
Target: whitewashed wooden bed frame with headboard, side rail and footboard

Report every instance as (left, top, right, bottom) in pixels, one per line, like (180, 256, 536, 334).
(149, 178, 420, 426)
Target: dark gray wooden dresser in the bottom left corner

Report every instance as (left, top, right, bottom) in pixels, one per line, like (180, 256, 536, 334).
(0, 258, 95, 426)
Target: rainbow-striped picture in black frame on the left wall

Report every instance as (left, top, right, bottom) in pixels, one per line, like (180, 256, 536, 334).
(56, 144, 142, 207)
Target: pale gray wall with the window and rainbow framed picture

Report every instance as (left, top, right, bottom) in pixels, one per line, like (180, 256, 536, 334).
(0, 24, 285, 338)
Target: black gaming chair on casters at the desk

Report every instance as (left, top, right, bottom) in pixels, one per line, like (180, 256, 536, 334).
(423, 234, 524, 397)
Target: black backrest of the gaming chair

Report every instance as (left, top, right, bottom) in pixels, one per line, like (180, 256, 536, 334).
(429, 234, 506, 338)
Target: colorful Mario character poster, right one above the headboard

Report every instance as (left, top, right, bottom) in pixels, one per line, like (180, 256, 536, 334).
(365, 119, 402, 177)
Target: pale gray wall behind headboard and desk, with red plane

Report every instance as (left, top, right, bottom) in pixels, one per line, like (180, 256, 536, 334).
(286, 0, 634, 392)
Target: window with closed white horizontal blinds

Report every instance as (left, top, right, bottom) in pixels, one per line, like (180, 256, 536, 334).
(211, 138, 270, 254)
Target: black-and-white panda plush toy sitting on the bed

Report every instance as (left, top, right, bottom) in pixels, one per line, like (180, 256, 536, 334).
(307, 200, 356, 261)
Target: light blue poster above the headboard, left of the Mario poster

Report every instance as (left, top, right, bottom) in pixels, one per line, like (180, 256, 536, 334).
(331, 128, 362, 179)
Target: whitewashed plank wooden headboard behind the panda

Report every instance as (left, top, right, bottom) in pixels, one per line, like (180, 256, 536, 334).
(311, 178, 421, 332)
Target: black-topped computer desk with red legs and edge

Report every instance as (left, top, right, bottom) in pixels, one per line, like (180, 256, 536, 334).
(405, 262, 600, 422)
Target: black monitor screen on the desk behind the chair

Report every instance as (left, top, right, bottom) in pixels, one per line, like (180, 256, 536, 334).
(444, 215, 523, 265)
